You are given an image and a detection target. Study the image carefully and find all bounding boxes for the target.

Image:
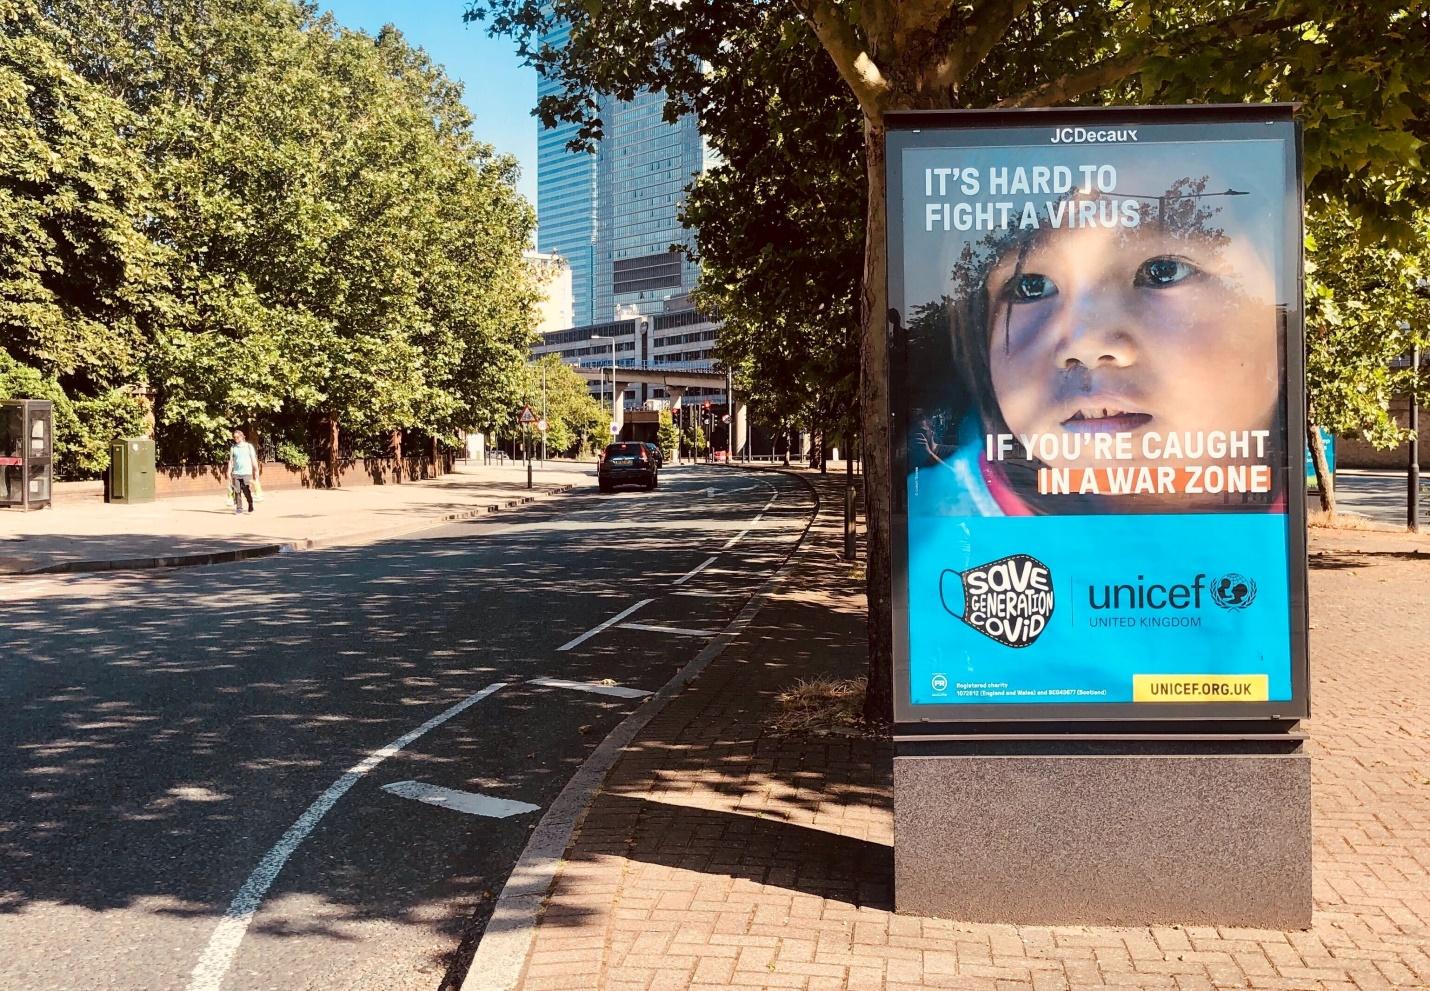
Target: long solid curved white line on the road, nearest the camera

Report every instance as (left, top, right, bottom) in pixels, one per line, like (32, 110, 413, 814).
(189, 682, 506, 991)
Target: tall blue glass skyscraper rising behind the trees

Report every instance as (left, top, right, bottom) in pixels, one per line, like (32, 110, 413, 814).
(536, 26, 706, 326)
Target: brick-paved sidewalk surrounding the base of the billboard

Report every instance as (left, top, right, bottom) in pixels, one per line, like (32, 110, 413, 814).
(509, 479, 1430, 991)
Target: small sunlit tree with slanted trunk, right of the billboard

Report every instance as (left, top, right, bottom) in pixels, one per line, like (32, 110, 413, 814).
(1306, 203, 1430, 513)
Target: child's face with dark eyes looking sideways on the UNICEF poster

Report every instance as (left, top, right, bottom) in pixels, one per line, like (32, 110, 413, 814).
(988, 218, 1280, 466)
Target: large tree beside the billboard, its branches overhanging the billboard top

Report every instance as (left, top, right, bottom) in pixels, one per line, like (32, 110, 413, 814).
(466, 0, 1430, 719)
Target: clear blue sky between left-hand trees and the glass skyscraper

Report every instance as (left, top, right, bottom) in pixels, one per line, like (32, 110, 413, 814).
(319, 0, 536, 206)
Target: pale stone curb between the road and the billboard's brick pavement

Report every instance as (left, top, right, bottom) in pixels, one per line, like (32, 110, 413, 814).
(460, 468, 822, 991)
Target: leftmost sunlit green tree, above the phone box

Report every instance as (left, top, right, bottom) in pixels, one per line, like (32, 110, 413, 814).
(0, 0, 160, 478)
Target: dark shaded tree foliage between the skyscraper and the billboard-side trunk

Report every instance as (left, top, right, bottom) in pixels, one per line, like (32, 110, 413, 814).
(682, 17, 864, 443)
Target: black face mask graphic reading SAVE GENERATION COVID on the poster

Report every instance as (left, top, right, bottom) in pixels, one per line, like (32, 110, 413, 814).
(938, 553, 1052, 646)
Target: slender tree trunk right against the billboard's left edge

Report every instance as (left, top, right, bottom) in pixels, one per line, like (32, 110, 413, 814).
(859, 117, 894, 724)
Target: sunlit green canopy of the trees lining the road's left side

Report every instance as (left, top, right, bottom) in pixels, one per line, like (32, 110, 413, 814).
(0, 0, 541, 475)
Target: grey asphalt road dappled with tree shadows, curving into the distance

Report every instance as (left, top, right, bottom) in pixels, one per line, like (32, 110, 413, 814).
(0, 466, 814, 991)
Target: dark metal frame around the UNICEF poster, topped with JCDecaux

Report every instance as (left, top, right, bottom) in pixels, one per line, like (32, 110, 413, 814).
(885, 103, 1310, 742)
